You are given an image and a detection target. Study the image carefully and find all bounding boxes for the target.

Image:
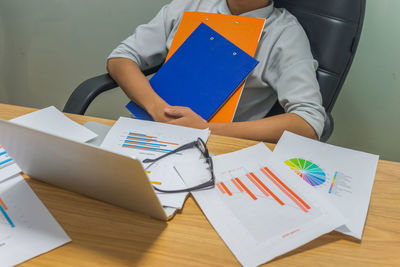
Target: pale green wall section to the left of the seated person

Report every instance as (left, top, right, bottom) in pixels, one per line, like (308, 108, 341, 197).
(0, 0, 170, 119)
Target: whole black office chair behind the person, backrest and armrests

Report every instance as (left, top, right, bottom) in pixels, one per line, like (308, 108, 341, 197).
(63, 0, 366, 142)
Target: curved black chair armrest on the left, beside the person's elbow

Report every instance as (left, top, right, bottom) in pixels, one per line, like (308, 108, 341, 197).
(63, 73, 118, 115)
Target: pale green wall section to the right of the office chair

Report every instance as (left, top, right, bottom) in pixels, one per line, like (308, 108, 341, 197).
(329, 0, 400, 161)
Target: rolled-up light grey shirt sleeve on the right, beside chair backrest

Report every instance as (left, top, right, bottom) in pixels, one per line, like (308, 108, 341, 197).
(265, 25, 326, 137)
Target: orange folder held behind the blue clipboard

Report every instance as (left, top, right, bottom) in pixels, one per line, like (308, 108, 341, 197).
(166, 11, 265, 122)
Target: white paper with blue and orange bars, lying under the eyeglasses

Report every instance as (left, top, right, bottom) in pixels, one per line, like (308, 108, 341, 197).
(101, 117, 210, 209)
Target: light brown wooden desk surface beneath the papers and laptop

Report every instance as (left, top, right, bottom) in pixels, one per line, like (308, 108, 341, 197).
(0, 104, 400, 266)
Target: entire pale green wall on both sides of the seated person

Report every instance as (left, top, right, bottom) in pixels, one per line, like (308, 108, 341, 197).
(0, 0, 400, 161)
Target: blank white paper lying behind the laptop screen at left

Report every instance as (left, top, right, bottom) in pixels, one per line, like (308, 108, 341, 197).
(10, 106, 97, 143)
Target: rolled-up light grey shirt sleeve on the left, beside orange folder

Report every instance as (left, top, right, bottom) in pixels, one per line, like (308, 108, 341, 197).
(108, 5, 173, 69)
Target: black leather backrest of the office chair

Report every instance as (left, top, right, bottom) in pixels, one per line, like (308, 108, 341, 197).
(268, 0, 366, 115)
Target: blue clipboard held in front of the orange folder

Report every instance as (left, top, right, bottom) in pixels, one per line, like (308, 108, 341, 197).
(126, 23, 258, 120)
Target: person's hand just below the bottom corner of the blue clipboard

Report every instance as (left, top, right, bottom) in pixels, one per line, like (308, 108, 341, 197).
(164, 106, 209, 129)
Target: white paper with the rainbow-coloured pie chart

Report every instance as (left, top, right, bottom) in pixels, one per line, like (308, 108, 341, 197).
(273, 132, 379, 239)
